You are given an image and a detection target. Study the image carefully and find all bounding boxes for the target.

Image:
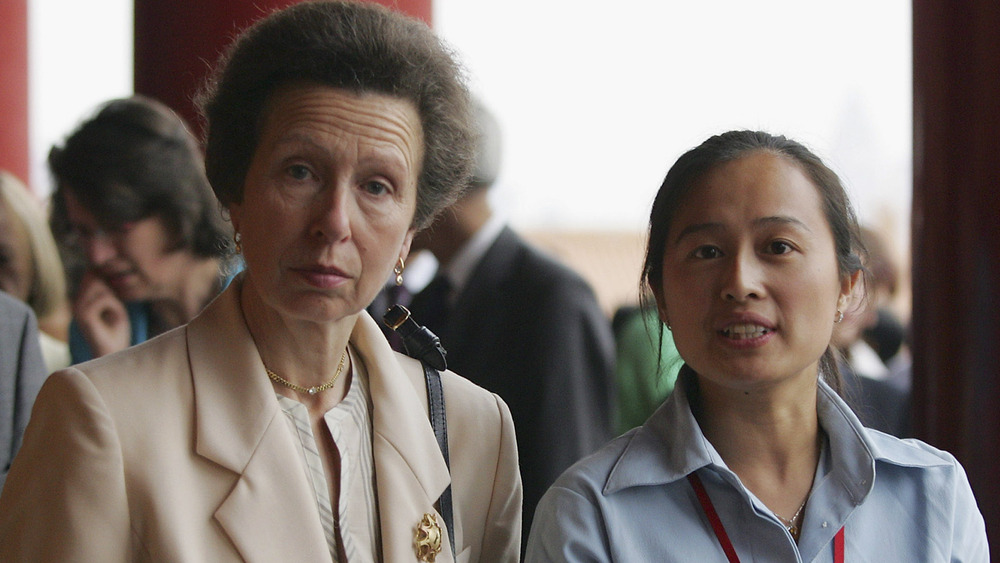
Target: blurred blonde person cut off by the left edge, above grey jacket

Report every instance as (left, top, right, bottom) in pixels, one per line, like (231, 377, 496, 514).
(0, 171, 70, 373)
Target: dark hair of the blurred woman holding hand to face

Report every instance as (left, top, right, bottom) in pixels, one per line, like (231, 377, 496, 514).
(49, 96, 230, 257)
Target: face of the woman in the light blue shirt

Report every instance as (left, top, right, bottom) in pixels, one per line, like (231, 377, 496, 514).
(657, 151, 852, 392)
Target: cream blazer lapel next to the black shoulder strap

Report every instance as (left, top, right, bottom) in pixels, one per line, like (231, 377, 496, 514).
(351, 311, 454, 563)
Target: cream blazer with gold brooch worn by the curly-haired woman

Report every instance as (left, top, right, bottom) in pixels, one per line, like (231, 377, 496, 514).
(0, 282, 521, 563)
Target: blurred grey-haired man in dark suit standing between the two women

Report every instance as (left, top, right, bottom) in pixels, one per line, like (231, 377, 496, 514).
(402, 100, 614, 548)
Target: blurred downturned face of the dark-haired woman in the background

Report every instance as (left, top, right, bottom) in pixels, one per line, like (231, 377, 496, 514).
(60, 189, 191, 301)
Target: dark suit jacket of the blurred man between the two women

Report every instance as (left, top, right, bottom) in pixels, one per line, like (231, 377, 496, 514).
(414, 227, 615, 536)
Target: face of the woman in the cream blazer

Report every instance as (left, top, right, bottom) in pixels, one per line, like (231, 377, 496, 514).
(230, 85, 423, 323)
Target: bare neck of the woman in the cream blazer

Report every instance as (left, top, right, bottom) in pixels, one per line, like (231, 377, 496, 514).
(240, 275, 357, 412)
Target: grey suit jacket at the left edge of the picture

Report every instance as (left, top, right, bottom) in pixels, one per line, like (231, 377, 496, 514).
(0, 292, 48, 489)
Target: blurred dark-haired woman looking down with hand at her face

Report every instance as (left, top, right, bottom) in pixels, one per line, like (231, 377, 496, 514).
(49, 96, 230, 363)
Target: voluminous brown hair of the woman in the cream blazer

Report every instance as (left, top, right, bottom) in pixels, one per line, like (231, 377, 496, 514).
(197, 2, 475, 228)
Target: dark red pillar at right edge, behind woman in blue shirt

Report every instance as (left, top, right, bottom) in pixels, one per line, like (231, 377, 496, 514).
(913, 0, 1000, 552)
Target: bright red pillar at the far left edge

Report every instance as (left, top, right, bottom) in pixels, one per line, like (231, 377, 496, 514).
(0, 0, 31, 185)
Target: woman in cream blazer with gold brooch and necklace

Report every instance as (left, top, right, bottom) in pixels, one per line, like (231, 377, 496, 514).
(0, 2, 521, 561)
